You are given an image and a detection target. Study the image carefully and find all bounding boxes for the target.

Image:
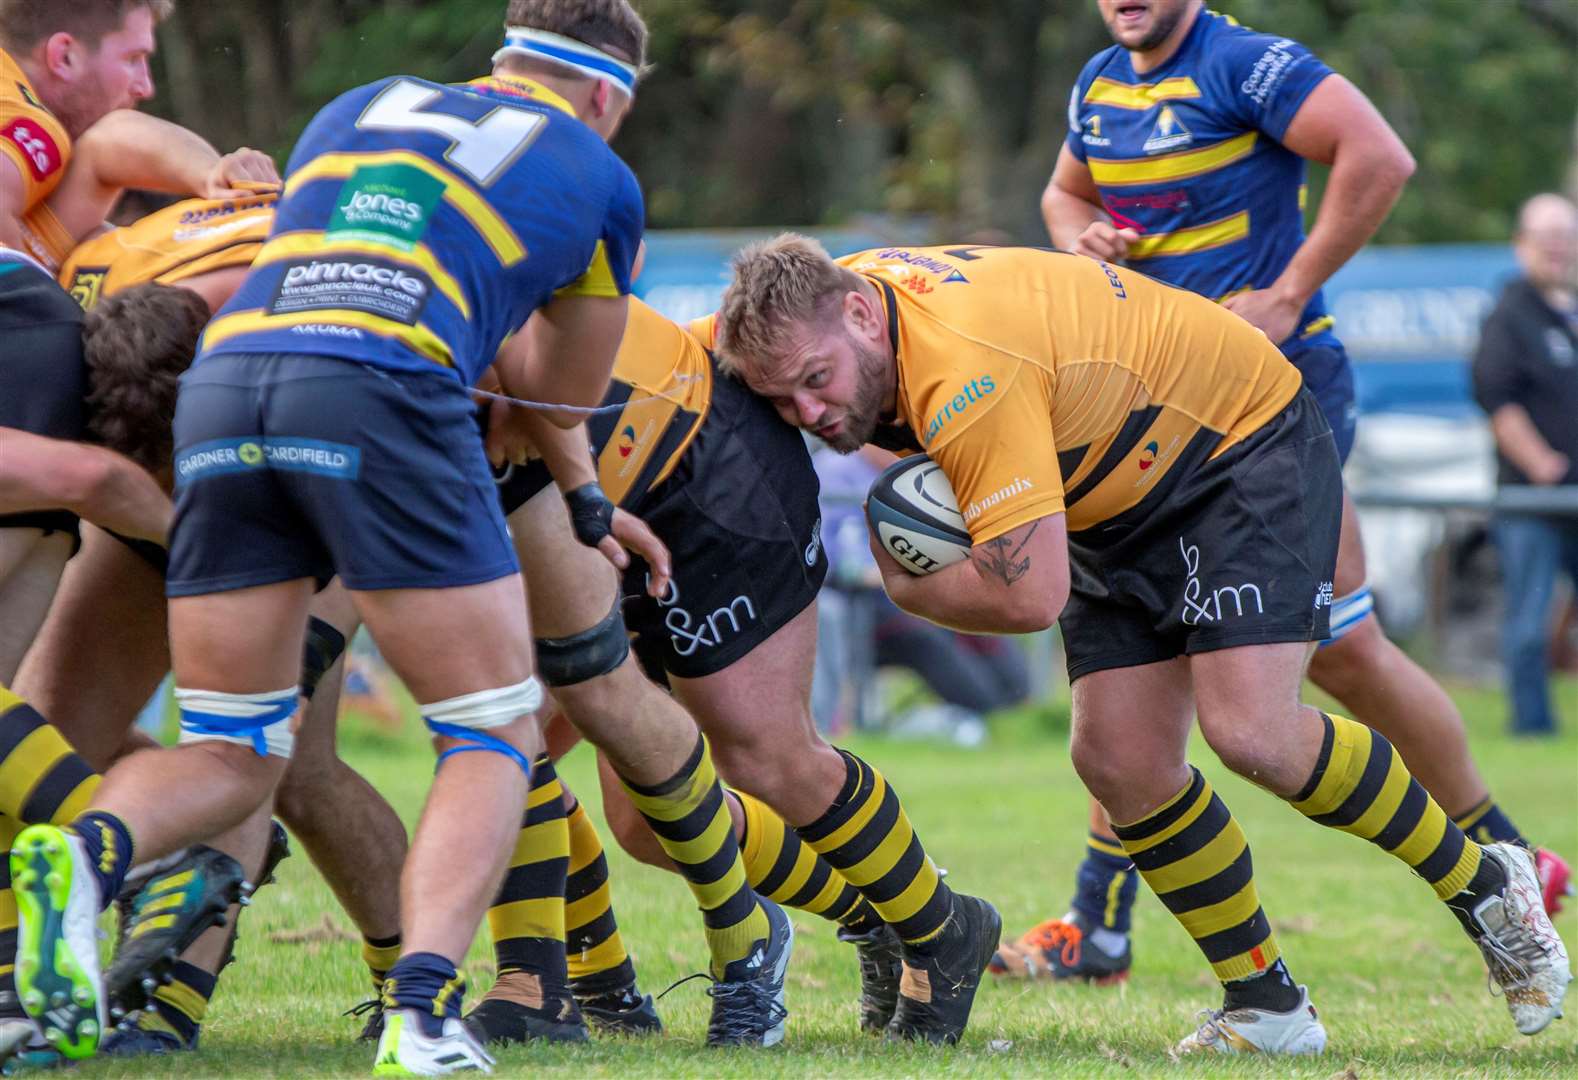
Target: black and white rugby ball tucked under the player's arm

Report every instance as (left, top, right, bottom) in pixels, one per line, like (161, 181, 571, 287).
(866, 453, 970, 573)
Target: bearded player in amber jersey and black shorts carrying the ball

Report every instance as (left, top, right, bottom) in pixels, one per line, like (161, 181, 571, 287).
(718, 235, 1572, 1053)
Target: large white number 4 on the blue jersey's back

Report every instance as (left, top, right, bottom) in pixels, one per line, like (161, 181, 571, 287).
(357, 79, 548, 188)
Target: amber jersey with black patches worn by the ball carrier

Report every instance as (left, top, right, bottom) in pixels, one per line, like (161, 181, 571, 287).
(839, 248, 1300, 543)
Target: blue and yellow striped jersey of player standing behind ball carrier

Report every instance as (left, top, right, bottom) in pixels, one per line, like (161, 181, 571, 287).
(1067, 11, 1335, 355)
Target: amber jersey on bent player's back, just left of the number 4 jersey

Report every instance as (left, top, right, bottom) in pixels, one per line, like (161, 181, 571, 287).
(60, 191, 278, 308)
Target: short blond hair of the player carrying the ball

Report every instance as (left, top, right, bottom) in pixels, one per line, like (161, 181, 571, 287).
(716, 232, 860, 374)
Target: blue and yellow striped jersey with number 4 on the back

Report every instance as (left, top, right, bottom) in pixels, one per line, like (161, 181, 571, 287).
(199, 76, 644, 385)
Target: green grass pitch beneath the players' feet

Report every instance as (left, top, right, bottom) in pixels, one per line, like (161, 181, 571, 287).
(61, 682, 1578, 1078)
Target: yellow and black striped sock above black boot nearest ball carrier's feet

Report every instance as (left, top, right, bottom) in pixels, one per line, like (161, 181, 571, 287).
(795, 750, 953, 944)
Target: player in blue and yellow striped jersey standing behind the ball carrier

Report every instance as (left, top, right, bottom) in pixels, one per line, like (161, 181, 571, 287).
(1022, 0, 1570, 981)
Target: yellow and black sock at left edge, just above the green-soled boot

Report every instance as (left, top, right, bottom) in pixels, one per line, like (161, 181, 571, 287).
(0, 685, 101, 824)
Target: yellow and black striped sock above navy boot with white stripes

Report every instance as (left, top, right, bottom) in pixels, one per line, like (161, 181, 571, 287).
(625, 736, 772, 979)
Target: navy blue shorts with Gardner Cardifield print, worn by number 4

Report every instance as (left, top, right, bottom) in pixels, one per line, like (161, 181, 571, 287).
(166, 354, 519, 597)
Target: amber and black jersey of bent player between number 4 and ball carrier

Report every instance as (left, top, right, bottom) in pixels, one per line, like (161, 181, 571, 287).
(587, 297, 713, 507)
